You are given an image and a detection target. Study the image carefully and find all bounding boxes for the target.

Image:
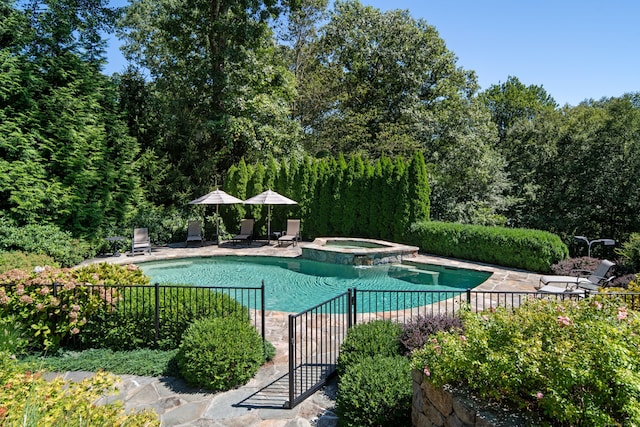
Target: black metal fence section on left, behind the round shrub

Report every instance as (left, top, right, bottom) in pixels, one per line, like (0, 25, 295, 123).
(0, 282, 265, 349)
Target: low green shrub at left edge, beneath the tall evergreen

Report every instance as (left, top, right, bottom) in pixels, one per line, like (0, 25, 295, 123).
(0, 218, 95, 267)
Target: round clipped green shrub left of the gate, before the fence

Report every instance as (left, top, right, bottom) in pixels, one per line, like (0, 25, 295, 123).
(176, 317, 265, 391)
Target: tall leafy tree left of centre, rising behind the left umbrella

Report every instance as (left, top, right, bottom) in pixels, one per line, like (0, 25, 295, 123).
(122, 0, 299, 203)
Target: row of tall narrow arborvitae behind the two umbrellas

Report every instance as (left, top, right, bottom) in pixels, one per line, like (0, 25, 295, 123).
(221, 153, 431, 242)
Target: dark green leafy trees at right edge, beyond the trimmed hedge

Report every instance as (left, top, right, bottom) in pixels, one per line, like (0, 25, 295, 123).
(506, 94, 640, 240)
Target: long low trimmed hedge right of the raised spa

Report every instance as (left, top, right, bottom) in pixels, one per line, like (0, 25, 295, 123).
(408, 221, 569, 273)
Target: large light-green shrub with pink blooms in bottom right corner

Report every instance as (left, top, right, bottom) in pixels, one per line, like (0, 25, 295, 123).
(412, 297, 640, 426)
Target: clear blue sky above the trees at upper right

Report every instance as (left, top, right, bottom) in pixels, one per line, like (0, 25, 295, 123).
(105, 0, 640, 105)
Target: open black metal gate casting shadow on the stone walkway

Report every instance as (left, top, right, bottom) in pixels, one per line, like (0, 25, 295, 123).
(285, 291, 352, 409)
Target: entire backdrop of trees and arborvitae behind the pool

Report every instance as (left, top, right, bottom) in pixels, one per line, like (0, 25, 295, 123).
(0, 0, 640, 247)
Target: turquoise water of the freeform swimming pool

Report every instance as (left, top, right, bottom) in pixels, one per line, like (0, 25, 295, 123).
(139, 256, 491, 312)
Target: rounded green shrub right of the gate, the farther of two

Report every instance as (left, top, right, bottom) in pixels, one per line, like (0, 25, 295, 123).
(337, 320, 402, 375)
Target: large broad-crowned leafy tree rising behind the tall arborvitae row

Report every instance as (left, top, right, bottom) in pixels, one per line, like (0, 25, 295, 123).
(298, 1, 508, 223)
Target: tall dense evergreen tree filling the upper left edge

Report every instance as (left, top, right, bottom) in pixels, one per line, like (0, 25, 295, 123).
(0, 0, 141, 237)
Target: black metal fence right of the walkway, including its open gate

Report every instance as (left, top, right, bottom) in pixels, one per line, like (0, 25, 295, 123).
(286, 289, 640, 408)
